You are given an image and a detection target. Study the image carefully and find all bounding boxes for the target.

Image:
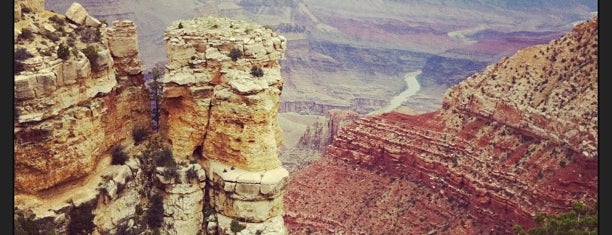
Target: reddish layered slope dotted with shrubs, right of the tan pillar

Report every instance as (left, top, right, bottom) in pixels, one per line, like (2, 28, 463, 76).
(286, 17, 598, 234)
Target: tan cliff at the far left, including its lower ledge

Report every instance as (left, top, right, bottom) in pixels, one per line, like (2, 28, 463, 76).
(14, 1, 151, 234)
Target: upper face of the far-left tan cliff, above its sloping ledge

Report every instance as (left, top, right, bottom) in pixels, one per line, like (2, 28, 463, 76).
(14, 4, 150, 193)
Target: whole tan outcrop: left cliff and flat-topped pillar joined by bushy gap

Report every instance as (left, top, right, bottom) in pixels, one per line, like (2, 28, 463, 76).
(14, 3, 289, 234)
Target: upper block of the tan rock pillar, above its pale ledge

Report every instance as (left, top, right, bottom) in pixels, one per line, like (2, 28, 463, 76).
(161, 15, 286, 170)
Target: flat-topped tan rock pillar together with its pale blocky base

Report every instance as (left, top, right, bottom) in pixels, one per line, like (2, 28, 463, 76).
(160, 17, 288, 234)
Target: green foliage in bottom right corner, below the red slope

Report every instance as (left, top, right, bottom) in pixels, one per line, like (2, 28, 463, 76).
(512, 202, 598, 235)
